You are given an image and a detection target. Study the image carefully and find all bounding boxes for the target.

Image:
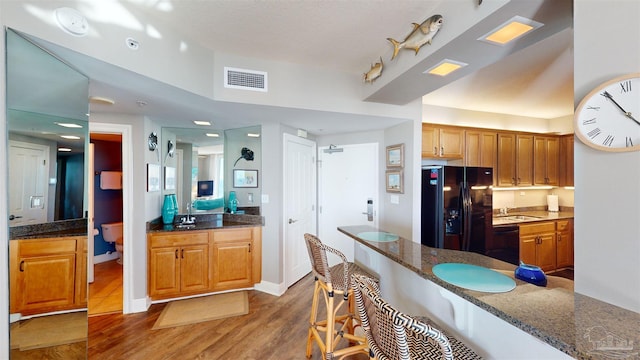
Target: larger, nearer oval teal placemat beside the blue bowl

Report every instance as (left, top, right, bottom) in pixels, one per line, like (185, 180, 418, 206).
(433, 263, 516, 293)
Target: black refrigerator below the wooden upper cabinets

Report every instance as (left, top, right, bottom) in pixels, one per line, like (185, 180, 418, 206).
(422, 165, 493, 254)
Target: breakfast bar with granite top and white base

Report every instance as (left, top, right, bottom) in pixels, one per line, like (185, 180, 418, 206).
(338, 226, 640, 359)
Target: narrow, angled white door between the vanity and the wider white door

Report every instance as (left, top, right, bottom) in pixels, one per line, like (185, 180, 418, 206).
(283, 134, 317, 287)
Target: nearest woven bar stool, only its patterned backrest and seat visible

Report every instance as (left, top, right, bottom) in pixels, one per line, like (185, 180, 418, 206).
(351, 274, 482, 360)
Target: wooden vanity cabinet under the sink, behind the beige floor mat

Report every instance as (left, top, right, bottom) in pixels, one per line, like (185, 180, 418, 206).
(148, 227, 262, 299)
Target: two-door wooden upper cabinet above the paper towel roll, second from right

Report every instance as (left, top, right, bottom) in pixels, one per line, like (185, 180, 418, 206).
(533, 136, 560, 186)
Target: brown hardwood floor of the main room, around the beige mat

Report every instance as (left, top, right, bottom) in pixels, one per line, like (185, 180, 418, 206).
(88, 274, 368, 360)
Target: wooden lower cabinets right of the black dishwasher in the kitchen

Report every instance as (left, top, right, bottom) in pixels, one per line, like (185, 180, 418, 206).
(520, 219, 573, 271)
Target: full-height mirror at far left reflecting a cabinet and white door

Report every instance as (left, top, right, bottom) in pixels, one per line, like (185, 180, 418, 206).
(5, 29, 89, 358)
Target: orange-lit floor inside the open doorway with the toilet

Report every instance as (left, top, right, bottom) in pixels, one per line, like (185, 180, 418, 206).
(88, 260, 122, 316)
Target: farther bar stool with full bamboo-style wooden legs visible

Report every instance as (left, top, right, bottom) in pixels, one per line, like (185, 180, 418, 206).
(304, 234, 372, 359)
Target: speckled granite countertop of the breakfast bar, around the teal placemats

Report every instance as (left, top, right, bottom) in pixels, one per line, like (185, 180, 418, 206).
(338, 226, 640, 359)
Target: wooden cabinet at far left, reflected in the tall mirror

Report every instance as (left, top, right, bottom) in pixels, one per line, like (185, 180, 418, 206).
(9, 237, 87, 315)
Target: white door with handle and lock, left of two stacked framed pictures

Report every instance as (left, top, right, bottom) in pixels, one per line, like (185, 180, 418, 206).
(318, 143, 380, 265)
